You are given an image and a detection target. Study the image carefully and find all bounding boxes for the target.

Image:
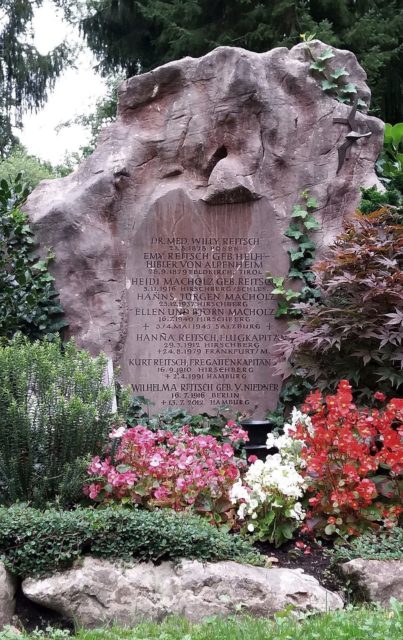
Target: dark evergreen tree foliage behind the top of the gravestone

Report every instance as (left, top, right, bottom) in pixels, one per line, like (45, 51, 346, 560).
(73, 0, 403, 122)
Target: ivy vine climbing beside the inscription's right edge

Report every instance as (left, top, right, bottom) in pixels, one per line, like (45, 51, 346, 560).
(266, 191, 320, 318)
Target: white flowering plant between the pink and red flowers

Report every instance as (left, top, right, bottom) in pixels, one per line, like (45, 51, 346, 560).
(231, 410, 309, 547)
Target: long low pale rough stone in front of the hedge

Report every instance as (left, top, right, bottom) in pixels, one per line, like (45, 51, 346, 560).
(22, 558, 343, 627)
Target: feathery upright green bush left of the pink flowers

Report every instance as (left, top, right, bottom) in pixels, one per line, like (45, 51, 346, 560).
(0, 336, 115, 506)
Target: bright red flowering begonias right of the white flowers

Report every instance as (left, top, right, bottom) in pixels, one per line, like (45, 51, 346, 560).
(289, 380, 403, 535)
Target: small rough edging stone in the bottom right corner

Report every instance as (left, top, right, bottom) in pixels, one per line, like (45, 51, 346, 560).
(341, 558, 403, 607)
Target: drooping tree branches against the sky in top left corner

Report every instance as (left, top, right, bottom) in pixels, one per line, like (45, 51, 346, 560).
(0, 0, 69, 157)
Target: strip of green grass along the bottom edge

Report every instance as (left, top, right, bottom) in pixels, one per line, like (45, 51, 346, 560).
(0, 601, 403, 640)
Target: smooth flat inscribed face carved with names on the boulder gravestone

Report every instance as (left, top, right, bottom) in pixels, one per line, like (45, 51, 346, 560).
(123, 192, 286, 417)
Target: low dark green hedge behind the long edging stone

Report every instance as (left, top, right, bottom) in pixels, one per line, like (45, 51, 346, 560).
(0, 506, 264, 578)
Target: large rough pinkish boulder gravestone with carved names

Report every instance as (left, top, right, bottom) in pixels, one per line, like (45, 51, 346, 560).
(23, 41, 382, 418)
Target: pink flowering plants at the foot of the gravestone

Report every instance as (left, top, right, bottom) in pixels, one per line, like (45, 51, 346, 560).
(84, 422, 248, 522)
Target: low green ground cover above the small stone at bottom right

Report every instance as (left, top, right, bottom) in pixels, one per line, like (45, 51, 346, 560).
(327, 527, 403, 562)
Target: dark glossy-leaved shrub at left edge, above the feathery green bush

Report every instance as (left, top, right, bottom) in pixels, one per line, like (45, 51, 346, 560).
(0, 173, 67, 343)
